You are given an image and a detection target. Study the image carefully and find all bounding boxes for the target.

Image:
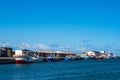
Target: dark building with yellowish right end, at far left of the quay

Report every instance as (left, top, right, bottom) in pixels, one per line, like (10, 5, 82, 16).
(0, 47, 13, 57)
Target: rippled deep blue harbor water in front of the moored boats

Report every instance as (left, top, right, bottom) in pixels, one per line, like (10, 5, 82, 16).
(0, 59, 120, 80)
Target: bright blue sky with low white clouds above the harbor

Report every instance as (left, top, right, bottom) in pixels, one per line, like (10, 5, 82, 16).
(0, 0, 120, 53)
